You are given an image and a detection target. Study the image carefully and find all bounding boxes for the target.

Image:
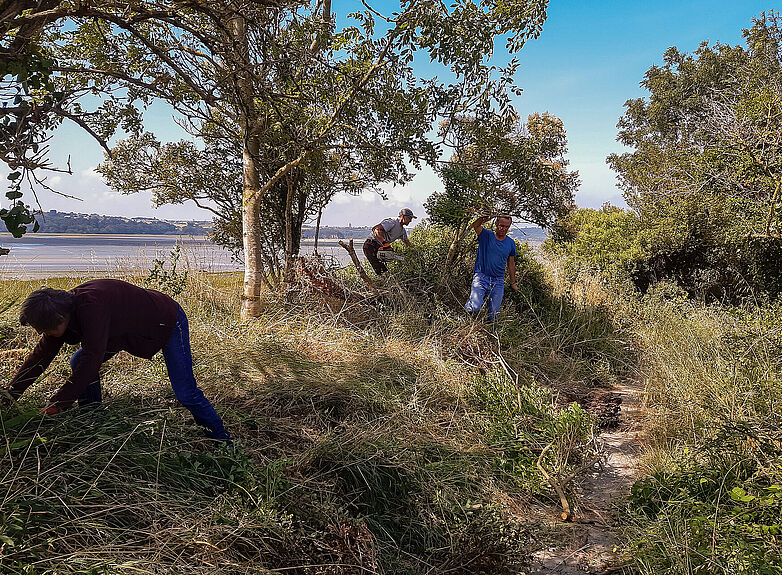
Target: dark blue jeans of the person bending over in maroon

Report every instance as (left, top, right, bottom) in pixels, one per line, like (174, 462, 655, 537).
(71, 304, 231, 441)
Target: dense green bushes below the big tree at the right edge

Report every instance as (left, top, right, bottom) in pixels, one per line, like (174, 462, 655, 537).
(544, 204, 782, 303)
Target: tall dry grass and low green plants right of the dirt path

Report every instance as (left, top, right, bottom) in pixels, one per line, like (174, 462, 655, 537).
(625, 296, 782, 574)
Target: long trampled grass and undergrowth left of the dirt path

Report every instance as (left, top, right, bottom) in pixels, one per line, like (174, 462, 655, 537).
(0, 254, 631, 574)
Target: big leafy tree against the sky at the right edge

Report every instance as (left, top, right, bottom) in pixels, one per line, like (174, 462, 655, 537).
(608, 12, 782, 241)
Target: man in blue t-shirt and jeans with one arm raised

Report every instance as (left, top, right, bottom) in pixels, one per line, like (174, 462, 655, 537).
(464, 216, 519, 322)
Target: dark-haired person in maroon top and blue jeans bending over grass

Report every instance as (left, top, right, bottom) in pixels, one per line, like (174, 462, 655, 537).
(1, 279, 231, 442)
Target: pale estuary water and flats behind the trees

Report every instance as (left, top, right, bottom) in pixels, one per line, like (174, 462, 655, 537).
(0, 233, 352, 279)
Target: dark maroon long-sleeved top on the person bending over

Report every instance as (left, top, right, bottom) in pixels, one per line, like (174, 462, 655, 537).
(10, 280, 177, 408)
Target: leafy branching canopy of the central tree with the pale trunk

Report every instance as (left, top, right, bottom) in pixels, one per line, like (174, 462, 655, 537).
(56, 0, 545, 297)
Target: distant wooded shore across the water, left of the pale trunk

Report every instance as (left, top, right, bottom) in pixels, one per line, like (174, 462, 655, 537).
(38, 210, 212, 236)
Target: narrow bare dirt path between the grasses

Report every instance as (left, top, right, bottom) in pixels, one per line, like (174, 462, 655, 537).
(528, 385, 641, 575)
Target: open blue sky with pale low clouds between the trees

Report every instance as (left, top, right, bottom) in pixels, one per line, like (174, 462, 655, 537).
(26, 0, 778, 226)
